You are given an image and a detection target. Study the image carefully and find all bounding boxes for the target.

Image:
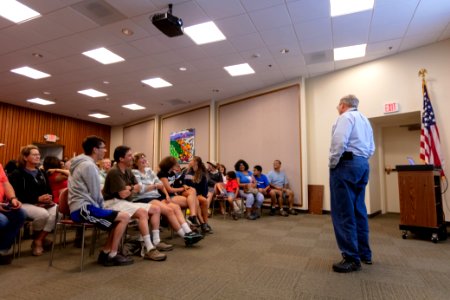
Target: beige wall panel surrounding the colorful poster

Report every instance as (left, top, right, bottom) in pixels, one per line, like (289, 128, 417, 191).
(159, 106, 210, 162)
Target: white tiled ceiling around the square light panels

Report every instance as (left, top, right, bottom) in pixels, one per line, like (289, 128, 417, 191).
(0, 0, 450, 125)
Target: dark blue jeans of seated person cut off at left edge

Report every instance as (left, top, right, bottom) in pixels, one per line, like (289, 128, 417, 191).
(0, 209, 26, 250)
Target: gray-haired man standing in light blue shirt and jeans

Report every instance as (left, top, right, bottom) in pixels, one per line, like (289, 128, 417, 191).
(329, 95, 375, 273)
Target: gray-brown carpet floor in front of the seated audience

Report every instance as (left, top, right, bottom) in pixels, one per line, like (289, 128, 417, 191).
(0, 212, 450, 300)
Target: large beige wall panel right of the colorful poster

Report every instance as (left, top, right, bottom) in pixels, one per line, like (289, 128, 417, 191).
(217, 84, 302, 204)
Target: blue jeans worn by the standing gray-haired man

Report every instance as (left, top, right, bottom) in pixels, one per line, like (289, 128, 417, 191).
(330, 156, 372, 261)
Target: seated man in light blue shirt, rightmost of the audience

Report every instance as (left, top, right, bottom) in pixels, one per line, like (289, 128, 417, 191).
(267, 159, 298, 217)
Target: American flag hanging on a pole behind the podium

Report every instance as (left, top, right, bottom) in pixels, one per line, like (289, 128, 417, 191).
(420, 82, 444, 176)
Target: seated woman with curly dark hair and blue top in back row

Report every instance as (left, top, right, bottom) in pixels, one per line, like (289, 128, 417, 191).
(234, 159, 264, 220)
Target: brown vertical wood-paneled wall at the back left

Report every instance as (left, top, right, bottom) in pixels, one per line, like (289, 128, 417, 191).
(0, 102, 111, 165)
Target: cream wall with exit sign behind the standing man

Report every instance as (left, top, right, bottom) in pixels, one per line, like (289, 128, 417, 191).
(306, 40, 450, 220)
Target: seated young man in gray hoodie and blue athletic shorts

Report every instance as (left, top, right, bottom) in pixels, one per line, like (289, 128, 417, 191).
(68, 136, 133, 266)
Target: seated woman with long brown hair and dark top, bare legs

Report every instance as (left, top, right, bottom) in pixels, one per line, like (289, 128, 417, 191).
(184, 156, 213, 233)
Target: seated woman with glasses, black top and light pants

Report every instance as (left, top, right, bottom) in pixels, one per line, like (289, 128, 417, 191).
(9, 145, 57, 256)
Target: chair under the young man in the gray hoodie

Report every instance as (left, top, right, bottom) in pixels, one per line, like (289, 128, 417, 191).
(48, 189, 97, 272)
